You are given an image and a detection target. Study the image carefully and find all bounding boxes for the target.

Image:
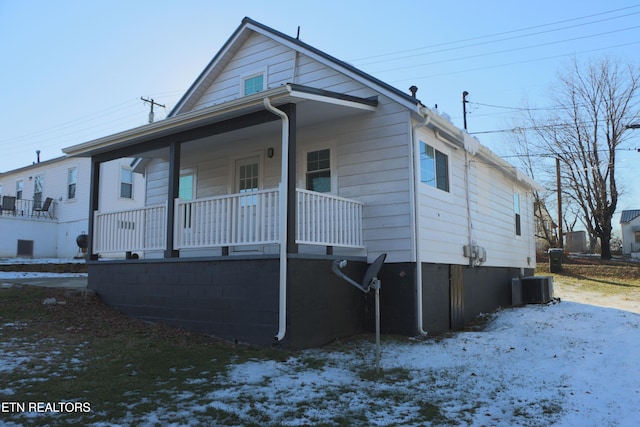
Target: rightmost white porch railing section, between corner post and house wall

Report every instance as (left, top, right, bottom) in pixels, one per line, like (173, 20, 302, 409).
(296, 188, 364, 248)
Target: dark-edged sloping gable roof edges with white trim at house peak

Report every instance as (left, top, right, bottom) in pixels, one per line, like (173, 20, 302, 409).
(167, 17, 422, 117)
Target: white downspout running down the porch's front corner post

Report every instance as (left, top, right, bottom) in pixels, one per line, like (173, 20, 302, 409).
(264, 98, 289, 341)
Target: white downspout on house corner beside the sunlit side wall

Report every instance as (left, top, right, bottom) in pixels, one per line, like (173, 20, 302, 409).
(411, 111, 431, 335)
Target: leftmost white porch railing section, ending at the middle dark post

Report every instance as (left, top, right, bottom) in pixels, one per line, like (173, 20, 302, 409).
(93, 204, 167, 253)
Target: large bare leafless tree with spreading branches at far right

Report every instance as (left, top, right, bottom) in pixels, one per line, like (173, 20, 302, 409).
(530, 58, 640, 259)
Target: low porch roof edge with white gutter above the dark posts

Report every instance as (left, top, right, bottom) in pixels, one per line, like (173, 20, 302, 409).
(63, 84, 377, 159)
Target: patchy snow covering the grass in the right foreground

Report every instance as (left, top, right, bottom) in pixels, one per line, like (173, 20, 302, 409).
(191, 302, 640, 426)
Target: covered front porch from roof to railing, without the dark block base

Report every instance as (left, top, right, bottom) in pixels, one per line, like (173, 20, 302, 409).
(67, 85, 377, 260)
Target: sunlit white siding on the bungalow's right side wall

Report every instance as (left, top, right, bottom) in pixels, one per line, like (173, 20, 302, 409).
(419, 125, 535, 268)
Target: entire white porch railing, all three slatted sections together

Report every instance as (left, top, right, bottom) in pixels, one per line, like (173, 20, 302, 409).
(93, 189, 364, 253)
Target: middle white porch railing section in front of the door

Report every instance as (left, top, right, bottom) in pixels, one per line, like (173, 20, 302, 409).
(174, 189, 280, 249)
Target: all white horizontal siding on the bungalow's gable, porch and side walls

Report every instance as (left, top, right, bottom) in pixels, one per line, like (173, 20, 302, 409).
(147, 29, 535, 267)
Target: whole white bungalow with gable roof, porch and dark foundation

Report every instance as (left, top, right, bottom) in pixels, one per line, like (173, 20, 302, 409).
(64, 18, 536, 348)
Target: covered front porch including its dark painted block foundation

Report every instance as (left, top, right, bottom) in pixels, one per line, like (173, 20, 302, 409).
(65, 85, 377, 348)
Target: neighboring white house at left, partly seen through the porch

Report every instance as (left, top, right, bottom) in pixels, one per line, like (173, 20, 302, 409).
(0, 157, 145, 258)
